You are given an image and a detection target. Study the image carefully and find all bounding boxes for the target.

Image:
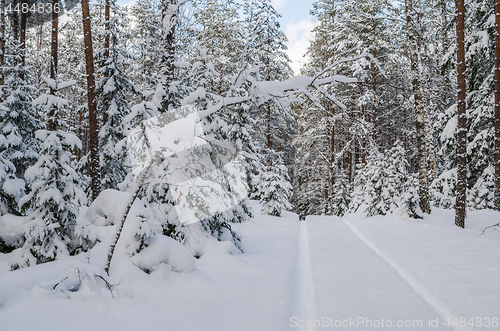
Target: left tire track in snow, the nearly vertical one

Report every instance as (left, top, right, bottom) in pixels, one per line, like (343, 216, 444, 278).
(290, 221, 316, 330)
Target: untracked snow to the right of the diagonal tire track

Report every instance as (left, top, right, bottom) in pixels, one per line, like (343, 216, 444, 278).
(346, 209, 500, 330)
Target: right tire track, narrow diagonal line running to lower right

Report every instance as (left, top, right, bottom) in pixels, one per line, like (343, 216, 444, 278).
(343, 219, 473, 331)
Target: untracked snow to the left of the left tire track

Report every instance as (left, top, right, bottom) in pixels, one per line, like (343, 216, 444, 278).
(0, 201, 298, 331)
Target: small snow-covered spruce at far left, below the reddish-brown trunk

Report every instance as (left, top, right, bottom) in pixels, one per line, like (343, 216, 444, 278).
(9, 130, 88, 269)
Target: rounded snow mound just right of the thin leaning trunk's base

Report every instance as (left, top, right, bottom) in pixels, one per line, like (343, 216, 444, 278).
(131, 235, 196, 273)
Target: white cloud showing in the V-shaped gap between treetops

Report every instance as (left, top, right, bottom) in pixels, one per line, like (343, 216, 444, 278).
(286, 20, 316, 75)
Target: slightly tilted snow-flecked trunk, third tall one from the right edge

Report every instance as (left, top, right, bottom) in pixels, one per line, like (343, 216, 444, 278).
(405, 0, 431, 214)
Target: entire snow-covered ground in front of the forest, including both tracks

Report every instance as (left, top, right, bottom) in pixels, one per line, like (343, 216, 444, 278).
(0, 204, 500, 331)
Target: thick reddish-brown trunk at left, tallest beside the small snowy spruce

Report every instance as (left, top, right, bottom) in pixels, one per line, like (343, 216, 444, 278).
(82, 0, 101, 200)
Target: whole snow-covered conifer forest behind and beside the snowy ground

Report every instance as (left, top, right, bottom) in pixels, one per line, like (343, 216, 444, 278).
(0, 0, 500, 330)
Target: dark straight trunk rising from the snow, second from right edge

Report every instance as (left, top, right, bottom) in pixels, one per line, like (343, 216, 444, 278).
(455, 0, 467, 228)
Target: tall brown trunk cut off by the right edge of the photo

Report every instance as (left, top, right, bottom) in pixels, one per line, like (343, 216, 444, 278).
(495, 0, 500, 211)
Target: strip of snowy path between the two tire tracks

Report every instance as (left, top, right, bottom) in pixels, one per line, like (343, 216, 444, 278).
(305, 216, 450, 330)
